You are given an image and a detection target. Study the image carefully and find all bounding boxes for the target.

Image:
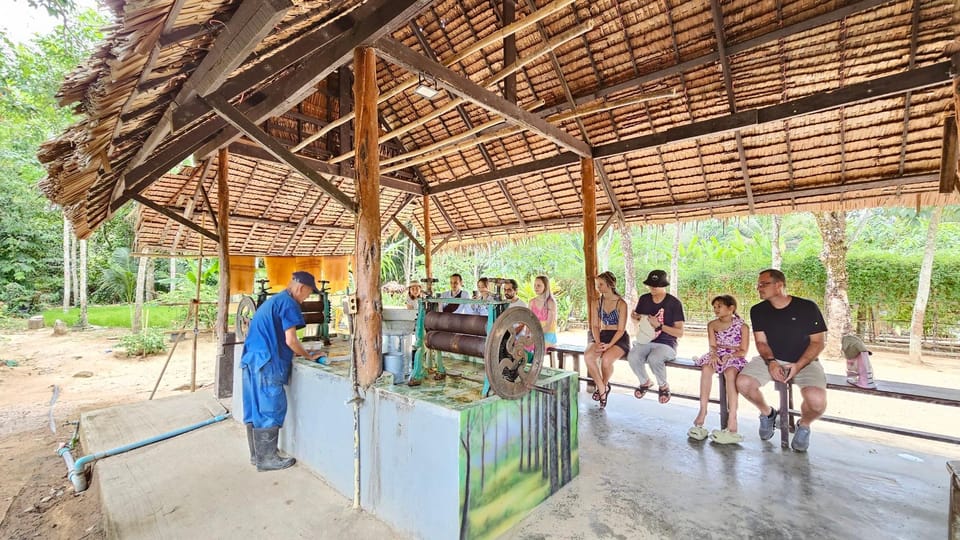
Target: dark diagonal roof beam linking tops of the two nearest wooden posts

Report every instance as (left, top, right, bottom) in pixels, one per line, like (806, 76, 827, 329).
(374, 38, 590, 157)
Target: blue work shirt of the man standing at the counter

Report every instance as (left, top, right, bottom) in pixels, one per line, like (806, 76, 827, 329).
(240, 291, 306, 384)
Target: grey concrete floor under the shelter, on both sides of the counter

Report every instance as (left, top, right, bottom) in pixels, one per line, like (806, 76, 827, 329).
(84, 394, 960, 540)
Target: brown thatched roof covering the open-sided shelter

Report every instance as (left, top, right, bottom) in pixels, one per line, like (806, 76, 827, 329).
(40, 0, 960, 255)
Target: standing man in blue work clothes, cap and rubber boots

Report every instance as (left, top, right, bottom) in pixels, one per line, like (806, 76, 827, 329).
(240, 272, 320, 471)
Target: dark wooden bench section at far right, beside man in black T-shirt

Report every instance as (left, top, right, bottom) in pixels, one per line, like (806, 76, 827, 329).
(774, 373, 960, 448)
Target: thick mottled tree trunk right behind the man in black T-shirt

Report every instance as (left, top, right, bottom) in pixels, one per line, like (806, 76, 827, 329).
(814, 211, 851, 359)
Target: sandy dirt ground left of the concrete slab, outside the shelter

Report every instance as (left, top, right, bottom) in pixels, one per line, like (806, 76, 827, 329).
(0, 328, 215, 540)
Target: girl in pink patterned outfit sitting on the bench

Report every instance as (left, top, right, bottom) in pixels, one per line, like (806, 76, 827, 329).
(687, 294, 750, 444)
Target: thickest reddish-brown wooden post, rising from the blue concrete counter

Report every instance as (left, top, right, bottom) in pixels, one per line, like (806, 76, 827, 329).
(353, 47, 383, 388)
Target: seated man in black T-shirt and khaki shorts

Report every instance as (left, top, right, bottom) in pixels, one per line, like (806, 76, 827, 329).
(737, 269, 827, 452)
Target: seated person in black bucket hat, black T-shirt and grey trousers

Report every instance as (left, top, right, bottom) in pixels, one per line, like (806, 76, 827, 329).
(627, 270, 684, 403)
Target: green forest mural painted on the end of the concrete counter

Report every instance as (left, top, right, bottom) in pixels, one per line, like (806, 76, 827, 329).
(460, 368, 580, 539)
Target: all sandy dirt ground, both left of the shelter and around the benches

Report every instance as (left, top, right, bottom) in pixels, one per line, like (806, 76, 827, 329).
(0, 328, 960, 539)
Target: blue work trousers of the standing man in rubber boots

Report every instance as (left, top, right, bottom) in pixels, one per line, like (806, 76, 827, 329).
(243, 361, 287, 429)
